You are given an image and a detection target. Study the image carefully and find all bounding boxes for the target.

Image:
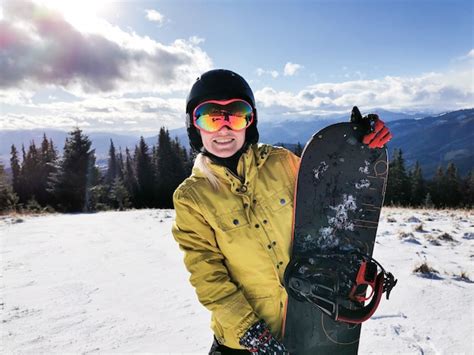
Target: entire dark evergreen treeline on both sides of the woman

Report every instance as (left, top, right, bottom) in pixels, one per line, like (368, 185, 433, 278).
(0, 136, 474, 212)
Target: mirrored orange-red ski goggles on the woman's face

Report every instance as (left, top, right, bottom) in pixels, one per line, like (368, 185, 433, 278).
(193, 99, 253, 133)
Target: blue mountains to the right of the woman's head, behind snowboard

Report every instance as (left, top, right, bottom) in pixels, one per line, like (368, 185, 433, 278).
(259, 109, 474, 178)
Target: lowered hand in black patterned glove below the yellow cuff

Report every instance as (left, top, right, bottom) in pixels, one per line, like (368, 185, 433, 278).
(240, 320, 289, 355)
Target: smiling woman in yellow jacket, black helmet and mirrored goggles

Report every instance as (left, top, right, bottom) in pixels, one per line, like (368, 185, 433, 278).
(172, 69, 391, 355)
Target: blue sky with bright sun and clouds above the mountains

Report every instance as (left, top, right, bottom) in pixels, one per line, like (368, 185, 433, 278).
(0, 0, 474, 135)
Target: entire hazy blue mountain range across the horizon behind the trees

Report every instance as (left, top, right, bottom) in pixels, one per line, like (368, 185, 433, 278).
(0, 109, 474, 178)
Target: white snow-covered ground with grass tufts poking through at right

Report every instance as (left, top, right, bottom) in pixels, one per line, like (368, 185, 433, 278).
(0, 208, 474, 354)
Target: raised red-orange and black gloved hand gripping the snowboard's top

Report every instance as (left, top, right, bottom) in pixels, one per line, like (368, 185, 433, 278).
(351, 106, 392, 148)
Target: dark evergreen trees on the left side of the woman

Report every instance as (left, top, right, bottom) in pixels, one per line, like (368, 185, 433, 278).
(0, 128, 192, 212)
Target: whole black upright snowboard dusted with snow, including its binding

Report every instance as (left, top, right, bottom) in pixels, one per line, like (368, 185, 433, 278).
(284, 112, 396, 355)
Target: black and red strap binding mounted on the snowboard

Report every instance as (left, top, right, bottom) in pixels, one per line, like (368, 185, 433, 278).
(285, 250, 397, 324)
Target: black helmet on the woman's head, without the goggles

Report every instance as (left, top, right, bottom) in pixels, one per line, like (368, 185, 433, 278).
(186, 69, 258, 152)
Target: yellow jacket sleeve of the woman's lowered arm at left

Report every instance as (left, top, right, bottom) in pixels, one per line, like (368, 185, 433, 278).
(172, 190, 259, 344)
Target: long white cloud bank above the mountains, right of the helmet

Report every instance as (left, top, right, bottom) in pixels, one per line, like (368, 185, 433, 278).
(255, 68, 474, 117)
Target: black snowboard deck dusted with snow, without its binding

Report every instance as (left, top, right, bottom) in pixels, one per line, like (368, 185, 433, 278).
(283, 123, 388, 355)
